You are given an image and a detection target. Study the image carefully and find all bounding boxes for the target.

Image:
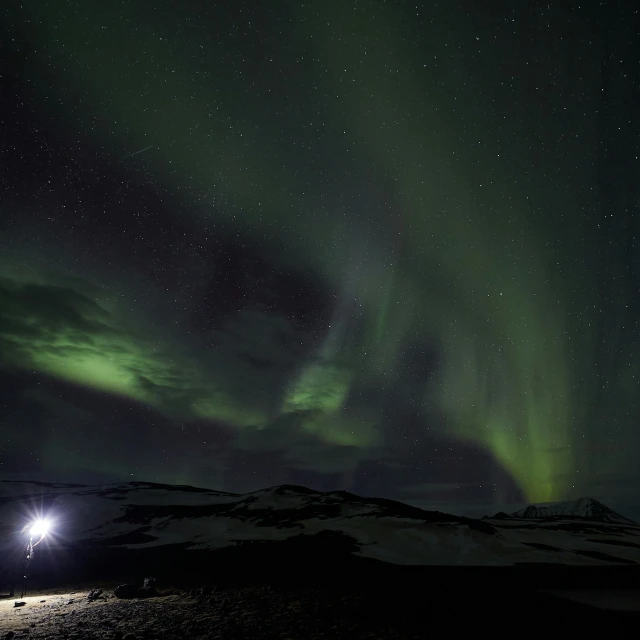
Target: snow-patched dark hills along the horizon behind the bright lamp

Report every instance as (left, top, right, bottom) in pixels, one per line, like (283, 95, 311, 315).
(0, 482, 640, 566)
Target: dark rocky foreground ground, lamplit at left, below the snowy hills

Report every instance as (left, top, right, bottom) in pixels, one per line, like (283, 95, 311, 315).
(0, 555, 640, 640)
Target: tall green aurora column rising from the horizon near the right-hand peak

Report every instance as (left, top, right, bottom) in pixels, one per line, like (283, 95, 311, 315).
(296, 4, 573, 501)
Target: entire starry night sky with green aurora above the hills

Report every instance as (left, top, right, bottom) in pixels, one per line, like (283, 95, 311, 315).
(0, 0, 640, 515)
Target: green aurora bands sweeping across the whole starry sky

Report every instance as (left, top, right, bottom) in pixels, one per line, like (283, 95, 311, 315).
(5, 1, 640, 501)
